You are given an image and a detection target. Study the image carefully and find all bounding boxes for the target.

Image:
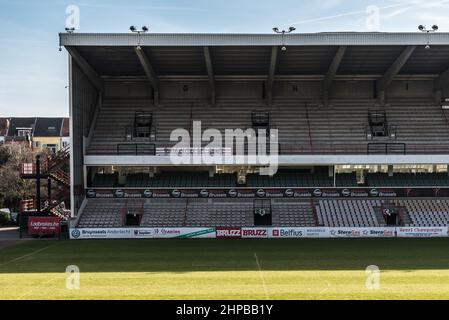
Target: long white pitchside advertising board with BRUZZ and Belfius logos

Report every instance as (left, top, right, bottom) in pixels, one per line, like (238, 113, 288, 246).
(70, 227, 449, 240)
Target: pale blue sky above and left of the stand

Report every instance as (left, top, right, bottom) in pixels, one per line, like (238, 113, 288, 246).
(0, 0, 449, 117)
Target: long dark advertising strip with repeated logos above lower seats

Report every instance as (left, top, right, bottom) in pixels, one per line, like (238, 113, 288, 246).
(86, 188, 449, 199)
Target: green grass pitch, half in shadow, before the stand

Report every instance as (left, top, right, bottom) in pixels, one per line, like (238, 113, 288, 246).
(0, 239, 449, 300)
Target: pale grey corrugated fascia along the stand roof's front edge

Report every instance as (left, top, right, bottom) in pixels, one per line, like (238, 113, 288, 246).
(60, 32, 449, 46)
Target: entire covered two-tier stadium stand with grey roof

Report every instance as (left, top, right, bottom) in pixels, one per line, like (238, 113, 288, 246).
(39, 32, 449, 238)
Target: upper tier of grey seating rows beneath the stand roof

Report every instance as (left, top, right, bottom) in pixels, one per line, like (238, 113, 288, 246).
(88, 99, 449, 155)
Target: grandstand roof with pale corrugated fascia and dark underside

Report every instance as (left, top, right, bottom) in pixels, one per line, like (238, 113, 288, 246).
(60, 33, 449, 80)
